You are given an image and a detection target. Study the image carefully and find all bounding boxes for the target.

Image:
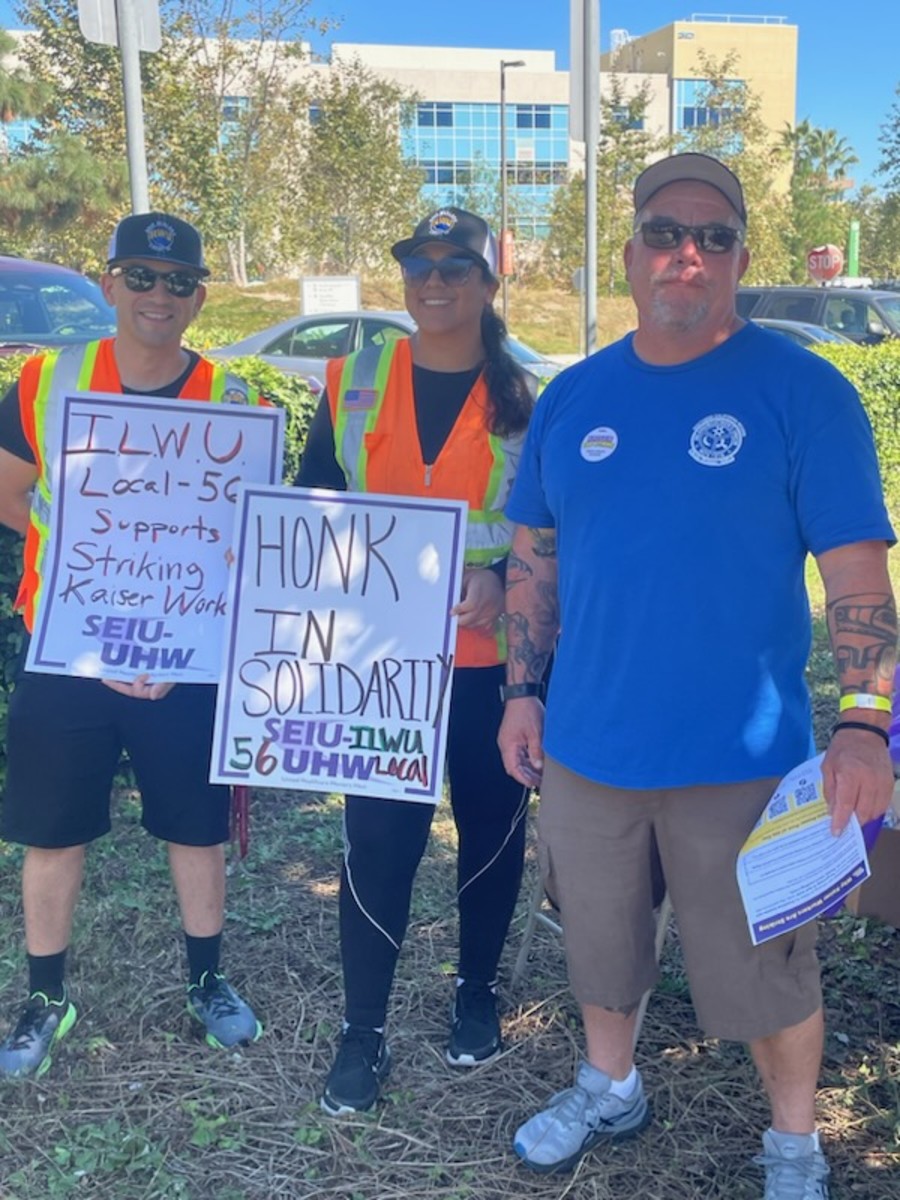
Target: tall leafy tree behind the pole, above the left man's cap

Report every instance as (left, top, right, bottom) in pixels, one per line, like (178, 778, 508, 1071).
(9, 0, 324, 282)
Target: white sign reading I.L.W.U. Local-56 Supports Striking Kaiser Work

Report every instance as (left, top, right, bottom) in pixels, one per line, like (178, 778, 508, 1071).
(28, 394, 284, 683)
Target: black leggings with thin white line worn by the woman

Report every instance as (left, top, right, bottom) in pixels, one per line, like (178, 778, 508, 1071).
(341, 666, 528, 1027)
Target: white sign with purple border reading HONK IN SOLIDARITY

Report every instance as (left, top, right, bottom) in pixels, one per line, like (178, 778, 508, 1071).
(210, 487, 467, 804)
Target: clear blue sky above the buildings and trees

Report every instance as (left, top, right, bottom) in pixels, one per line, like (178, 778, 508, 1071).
(0, 0, 900, 184)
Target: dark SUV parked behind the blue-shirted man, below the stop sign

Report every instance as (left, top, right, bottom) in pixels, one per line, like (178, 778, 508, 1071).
(737, 287, 900, 346)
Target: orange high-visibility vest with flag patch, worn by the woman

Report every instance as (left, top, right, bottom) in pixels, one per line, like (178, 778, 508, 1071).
(326, 338, 524, 666)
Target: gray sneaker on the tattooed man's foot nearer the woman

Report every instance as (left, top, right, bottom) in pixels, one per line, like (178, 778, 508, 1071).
(512, 1062, 650, 1175)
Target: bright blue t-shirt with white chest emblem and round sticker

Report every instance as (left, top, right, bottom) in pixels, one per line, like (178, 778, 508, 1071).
(506, 325, 893, 788)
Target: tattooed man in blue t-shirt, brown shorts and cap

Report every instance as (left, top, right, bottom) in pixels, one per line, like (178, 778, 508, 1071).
(500, 154, 896, 1200)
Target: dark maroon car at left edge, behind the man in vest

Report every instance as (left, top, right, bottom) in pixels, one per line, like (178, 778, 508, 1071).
(0, 256, 115, 355)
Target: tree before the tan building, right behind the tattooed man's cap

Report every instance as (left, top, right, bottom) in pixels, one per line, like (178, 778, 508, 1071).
(678, 54, 792, 283)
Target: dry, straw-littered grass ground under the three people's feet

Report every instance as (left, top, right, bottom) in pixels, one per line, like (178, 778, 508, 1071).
(0, 772, 900, 1200)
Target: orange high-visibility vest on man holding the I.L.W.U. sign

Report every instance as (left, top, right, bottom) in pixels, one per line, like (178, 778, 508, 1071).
(16, 337, 264, 632)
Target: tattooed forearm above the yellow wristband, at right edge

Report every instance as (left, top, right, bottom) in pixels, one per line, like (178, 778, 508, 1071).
(828, 593, 896, 696)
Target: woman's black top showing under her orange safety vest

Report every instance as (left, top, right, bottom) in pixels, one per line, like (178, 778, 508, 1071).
(294, 364, 481, 492)
